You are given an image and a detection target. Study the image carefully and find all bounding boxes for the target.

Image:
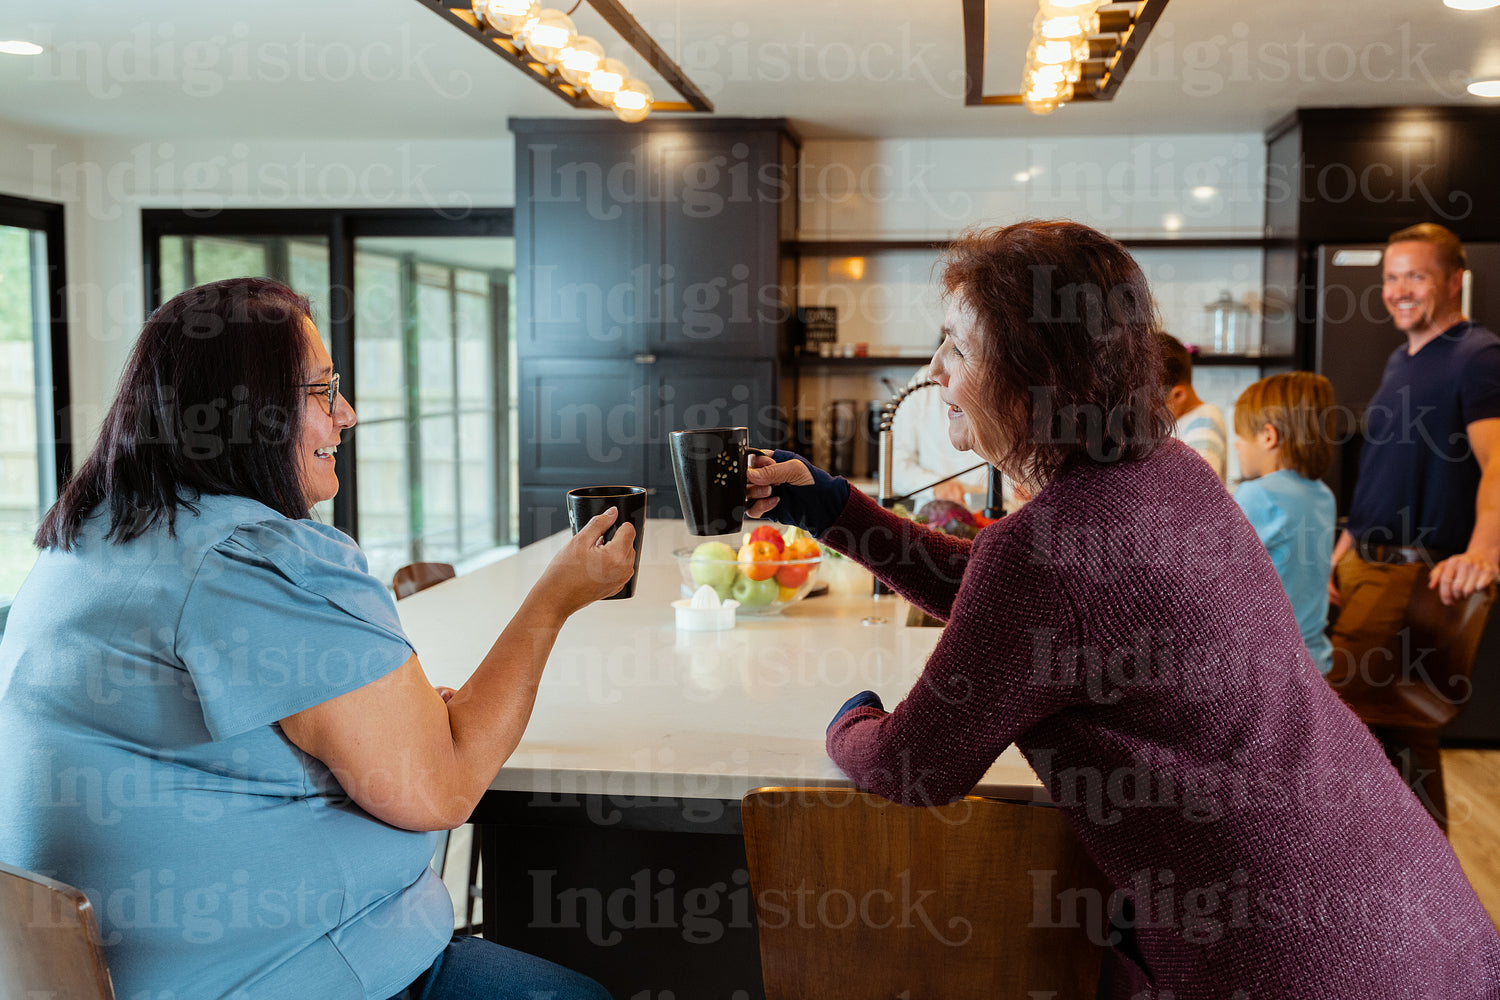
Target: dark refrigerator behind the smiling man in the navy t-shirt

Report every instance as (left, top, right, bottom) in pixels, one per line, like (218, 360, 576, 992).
(1313, 243, 1500, 745)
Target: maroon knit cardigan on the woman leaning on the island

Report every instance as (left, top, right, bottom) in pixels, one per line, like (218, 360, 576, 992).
(824, 441, 1500, 1000)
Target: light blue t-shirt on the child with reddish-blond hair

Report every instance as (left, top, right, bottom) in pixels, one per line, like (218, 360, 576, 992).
(1235, 469, 1335, 673)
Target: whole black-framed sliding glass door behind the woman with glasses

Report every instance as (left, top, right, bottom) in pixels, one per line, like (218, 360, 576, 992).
(143, 210, 516, 590)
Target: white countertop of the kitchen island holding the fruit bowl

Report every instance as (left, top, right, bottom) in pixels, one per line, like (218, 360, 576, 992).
(398, 520, 1046, 799)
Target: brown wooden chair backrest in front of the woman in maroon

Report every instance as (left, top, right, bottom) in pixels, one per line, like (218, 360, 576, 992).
(741, 789, 1110, 1000)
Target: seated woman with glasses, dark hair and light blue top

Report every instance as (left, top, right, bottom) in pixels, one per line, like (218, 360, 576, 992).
(0, 279, 633, 1000)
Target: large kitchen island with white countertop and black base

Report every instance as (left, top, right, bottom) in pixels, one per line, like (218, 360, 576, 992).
(398, 520, 1046, 1000)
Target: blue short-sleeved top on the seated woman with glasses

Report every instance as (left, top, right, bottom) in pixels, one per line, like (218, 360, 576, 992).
(0, 496, 453, 1000)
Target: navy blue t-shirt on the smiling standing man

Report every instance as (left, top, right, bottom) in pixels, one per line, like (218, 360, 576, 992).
(1349, 321, 1500, 553)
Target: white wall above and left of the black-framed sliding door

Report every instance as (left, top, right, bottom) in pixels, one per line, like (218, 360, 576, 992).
(0, 121, 515, 454)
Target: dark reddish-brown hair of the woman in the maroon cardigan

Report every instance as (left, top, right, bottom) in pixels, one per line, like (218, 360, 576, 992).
(944, 220, 1172, 481)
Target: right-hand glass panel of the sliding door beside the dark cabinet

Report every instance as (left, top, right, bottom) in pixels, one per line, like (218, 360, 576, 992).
(354, 237, 516, 587)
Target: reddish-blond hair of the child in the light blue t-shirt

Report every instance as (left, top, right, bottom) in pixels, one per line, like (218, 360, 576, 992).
(1235, 372, 1334, 480)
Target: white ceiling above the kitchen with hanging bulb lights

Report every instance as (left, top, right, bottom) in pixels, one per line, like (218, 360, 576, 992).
(0, 0, 1500, 139)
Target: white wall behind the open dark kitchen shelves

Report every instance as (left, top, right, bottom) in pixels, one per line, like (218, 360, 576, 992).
(788, 133, 1266, 482)
